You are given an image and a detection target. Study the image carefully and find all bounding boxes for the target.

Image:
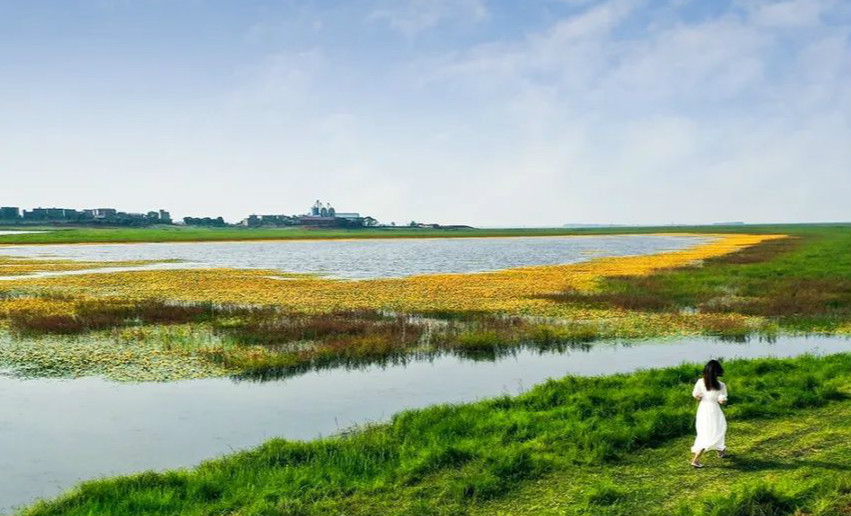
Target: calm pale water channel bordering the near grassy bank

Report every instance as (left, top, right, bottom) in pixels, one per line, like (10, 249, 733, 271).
(0, 337, 851, 512)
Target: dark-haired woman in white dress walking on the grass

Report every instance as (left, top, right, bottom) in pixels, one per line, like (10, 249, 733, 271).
(691, 360, 727, 468)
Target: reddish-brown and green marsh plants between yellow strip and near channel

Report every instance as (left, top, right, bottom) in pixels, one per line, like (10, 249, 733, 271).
(0, 298, 597, 381)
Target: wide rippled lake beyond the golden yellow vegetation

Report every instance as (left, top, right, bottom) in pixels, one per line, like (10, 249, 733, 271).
(0, 235, 710, 279)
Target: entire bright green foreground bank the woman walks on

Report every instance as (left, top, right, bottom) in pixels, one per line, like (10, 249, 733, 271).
(23, 354, 851, 516)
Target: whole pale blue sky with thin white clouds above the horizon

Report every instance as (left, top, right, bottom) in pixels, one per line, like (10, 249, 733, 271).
(0, 0, 851, 226)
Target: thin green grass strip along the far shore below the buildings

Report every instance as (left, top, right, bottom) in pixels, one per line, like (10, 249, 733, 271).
(0, 224, 851, 245)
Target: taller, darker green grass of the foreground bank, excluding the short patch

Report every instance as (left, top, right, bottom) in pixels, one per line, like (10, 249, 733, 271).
(18, 354, 851, 516)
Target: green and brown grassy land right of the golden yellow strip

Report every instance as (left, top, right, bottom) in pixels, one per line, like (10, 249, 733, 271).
(546, 226, 851, 332)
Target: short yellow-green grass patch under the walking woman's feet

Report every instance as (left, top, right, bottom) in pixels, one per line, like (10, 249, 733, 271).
(470, 374, 851, 516)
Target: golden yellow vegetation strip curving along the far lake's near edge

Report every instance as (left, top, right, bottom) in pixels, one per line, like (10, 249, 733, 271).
(0, 234, 783, 318)
